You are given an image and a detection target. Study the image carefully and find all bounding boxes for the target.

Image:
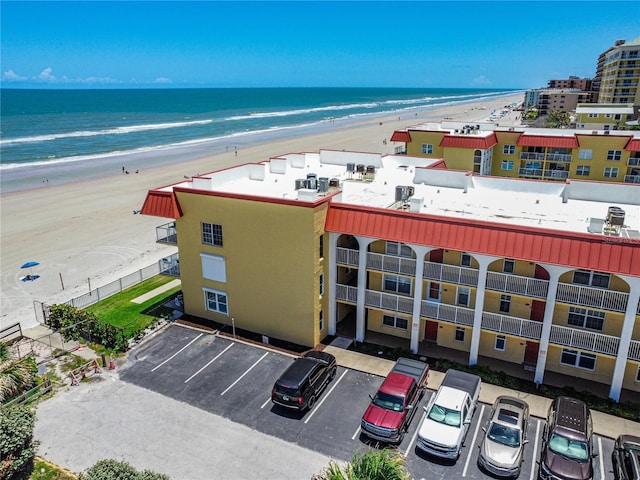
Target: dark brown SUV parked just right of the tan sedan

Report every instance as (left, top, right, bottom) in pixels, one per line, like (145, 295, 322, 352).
(538, 397, 595, 480)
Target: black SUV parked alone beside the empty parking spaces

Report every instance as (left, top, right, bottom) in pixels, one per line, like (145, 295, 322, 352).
(271, 350, 336, 410)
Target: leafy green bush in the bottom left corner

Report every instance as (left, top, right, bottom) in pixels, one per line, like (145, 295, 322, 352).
(0, 407, 35, 480)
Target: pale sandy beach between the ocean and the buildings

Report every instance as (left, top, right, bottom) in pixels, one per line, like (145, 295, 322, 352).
(0, 93, 522, 328)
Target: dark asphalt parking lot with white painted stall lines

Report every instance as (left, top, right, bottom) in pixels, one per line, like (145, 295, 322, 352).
(119, 325, 613, 480)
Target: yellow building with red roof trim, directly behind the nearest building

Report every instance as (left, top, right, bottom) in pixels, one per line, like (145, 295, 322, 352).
(391, 122, 640, 184)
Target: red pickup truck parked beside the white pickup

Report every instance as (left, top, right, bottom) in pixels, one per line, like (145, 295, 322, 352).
(360, 358, 429, 443)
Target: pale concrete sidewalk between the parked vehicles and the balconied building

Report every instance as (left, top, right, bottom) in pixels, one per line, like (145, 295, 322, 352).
(324, 345, 640, 439)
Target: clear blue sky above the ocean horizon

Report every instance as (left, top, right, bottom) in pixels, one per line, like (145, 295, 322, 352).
(0, 0, 640, 88)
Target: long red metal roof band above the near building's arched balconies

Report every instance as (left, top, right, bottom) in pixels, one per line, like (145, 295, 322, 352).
(325, 203, 640, 276)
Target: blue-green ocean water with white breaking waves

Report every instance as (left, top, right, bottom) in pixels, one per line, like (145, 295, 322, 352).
(0, 88, 513, 174)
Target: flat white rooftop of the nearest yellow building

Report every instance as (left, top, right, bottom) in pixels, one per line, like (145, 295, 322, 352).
(165, 150, 640, 238)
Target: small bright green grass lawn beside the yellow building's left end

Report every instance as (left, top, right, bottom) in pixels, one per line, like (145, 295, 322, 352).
(86, 275, 182, 336)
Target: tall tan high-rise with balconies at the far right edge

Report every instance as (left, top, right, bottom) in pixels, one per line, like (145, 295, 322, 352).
(596, 37, 640, 111)
